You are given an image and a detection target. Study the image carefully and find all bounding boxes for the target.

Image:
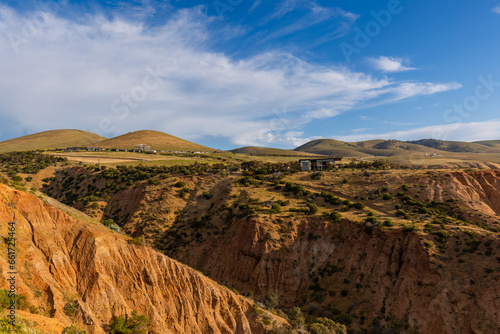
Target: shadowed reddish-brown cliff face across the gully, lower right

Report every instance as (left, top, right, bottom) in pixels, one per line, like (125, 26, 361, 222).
(173, 220, 500, 334)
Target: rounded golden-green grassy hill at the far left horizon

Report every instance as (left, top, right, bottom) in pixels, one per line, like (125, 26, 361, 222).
(0, 130, 106, 152)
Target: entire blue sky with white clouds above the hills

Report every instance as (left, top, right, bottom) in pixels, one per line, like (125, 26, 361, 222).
(0, 0, 500, 149)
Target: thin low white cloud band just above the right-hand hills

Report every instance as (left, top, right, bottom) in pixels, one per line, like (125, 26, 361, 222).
(332, 120, 500, 142)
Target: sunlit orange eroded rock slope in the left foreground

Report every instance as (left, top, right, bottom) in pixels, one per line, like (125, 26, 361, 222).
(0, 184, 283, 333)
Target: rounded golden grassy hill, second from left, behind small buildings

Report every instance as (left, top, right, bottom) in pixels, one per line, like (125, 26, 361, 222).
(99, 130, 214, 152)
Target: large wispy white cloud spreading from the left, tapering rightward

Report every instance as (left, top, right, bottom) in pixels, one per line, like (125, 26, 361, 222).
(0, 6, 456, 146)
